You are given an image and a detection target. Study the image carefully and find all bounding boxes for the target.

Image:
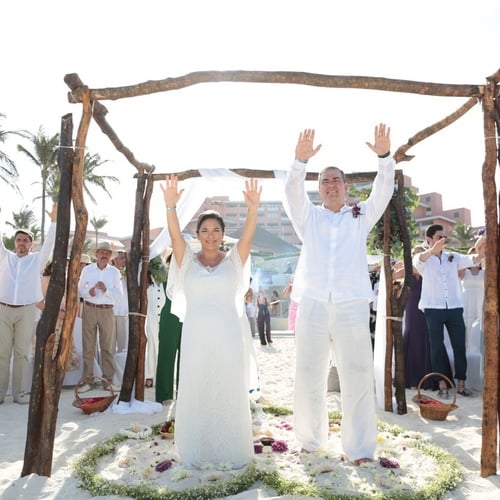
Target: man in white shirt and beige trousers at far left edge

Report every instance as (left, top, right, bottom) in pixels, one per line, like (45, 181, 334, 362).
(0, 204, 57, 404)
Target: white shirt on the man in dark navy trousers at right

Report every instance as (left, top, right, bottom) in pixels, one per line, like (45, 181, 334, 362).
(413, 251, 474, 311)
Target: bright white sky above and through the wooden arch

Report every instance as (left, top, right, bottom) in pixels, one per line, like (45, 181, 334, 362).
(0, 0, 500, 236)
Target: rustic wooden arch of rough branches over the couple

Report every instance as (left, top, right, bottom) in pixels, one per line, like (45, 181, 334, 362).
(22, 71, 500, 477)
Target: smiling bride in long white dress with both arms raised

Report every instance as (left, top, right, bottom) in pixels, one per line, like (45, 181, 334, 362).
(162, 175, 262, 468)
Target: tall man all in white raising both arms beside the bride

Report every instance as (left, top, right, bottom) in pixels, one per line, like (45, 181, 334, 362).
(285, 124, 395, 465)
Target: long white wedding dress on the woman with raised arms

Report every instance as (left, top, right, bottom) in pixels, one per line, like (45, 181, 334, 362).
(169, 247, 254, 468)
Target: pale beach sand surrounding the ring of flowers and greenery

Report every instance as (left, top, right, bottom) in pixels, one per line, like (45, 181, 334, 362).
(0, 332, 500, 500)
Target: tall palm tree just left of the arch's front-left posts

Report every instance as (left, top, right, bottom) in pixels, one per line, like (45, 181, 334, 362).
(17, 126, 60, 244)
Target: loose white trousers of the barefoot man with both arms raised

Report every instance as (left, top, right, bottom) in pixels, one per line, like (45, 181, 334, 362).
(294, 298, 377, 460)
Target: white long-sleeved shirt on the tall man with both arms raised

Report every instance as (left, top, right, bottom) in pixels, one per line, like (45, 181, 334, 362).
(285, 156, 395, 303)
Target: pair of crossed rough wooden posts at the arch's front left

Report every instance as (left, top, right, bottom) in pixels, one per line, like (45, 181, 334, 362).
(21, 84, 91, 476)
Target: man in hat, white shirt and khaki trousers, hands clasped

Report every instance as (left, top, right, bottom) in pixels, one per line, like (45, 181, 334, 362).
(78, 241, 123, 392)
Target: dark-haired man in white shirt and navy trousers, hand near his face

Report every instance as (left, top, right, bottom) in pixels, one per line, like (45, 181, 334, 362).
(413, 224, 484, 399)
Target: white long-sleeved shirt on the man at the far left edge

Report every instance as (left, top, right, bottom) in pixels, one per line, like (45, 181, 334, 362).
(0, 222, 56, 306)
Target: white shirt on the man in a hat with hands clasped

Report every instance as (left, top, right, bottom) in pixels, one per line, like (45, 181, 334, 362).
(78, 263, 123, 305)
